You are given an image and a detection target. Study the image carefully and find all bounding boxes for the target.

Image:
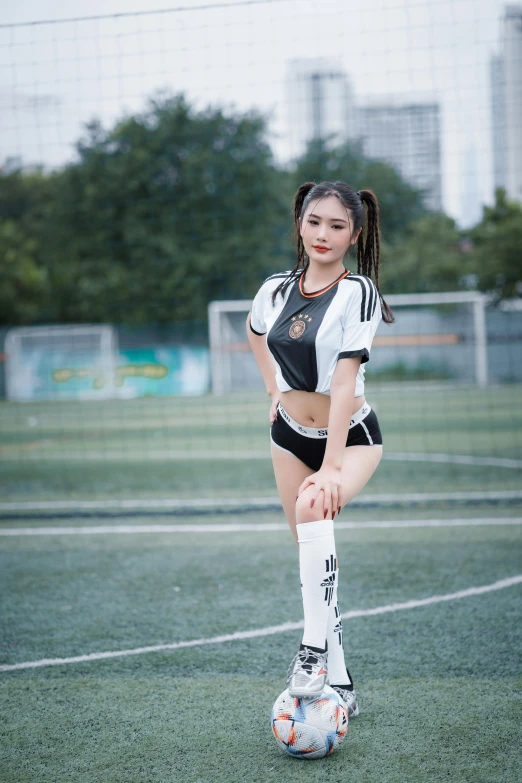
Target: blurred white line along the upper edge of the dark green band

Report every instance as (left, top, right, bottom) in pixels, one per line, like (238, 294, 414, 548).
(0, 489, 522, 513)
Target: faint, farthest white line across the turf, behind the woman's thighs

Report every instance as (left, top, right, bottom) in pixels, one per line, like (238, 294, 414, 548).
(0, 450, 522, 469)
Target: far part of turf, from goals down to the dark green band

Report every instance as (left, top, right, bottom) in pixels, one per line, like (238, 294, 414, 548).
(0, 384, 522, 501)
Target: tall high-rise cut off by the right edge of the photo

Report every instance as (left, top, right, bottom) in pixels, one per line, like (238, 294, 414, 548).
(490, 5, 522, 202)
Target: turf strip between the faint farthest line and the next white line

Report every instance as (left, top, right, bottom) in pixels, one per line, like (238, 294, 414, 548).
(0, 452, 521, 506)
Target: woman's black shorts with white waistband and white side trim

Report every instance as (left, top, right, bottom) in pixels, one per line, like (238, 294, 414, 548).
(270, 403, 382, 471)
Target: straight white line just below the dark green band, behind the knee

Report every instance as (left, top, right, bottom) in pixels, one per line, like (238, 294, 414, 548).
(0, 517, 522, 537)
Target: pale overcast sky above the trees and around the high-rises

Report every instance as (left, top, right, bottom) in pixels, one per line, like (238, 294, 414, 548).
(0, 0, 510, 224)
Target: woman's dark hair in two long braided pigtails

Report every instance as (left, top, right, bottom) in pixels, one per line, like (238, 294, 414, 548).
(272, 180, 395, 324)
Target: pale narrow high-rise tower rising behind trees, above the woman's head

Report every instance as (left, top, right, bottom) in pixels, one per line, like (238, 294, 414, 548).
(287, 58, 355, 157)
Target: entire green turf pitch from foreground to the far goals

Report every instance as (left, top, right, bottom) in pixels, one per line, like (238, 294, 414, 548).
(0, 386, 522, 783)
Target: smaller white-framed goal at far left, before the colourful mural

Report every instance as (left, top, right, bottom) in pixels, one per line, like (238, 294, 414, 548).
(5, 325, 122, 402)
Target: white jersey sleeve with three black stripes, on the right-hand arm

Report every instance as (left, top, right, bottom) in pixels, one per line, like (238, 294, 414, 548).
(338, 275, 382, 364)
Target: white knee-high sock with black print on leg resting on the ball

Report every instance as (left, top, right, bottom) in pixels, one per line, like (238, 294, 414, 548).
(297, 519, 337, 650)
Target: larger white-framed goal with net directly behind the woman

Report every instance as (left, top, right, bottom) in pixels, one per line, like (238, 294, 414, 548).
(208, 291, 488, 395)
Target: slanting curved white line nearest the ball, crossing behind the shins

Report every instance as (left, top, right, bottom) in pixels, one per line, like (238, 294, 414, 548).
(0, 574, 522, 672)
